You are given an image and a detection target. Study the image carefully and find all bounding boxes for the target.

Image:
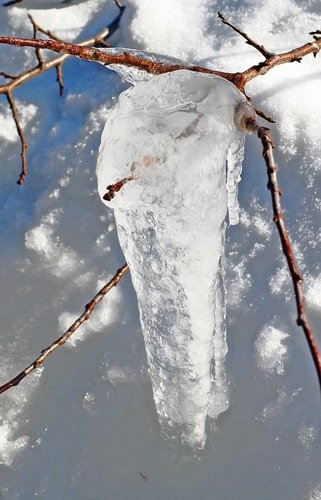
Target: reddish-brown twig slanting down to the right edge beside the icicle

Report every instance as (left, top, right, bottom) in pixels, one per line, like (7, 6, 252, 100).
(245, 119, 321, 388)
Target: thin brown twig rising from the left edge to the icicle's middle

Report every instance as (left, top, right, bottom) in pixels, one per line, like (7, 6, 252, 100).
(0, 264, 128, 394)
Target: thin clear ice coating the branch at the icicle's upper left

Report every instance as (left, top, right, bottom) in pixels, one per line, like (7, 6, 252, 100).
(101, 47, 183, 85)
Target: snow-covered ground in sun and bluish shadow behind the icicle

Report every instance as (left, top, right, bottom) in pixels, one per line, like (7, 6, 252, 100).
(0, 0, 321, 500)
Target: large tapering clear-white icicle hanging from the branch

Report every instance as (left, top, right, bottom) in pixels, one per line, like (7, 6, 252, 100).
(97, 70, 252, 447)
